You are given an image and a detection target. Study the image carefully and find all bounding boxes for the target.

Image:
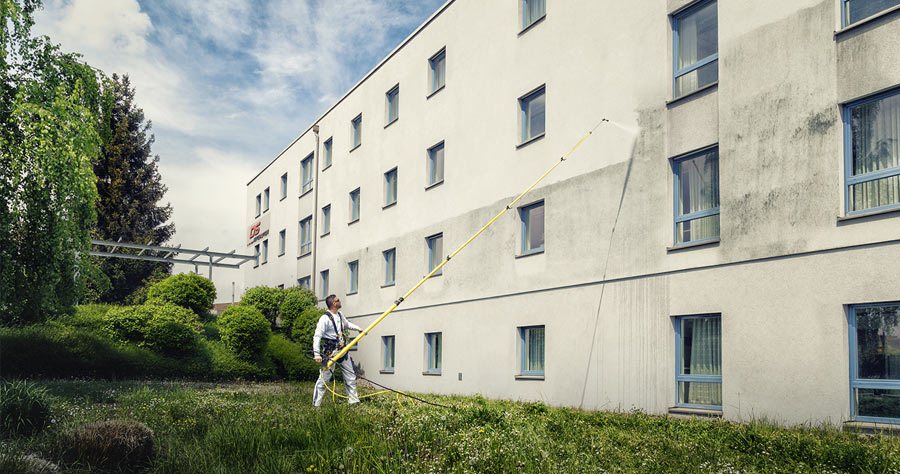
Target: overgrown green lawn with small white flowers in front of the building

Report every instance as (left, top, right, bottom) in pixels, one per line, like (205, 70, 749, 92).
(0, 381, 900, 474)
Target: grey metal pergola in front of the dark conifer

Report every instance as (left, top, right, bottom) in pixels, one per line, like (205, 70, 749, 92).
(91, 239, 259, 279)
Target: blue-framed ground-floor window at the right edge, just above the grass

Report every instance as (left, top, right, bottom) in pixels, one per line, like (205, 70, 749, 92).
(849, 302, 900, 423)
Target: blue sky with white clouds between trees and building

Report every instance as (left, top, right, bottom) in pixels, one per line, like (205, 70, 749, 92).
(33, 0, 445, 301)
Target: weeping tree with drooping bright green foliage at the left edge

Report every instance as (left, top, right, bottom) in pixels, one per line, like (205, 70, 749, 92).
(0, 0, 100, 324)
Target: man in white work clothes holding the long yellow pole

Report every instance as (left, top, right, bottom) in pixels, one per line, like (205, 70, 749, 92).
(313, 295, 362, 407)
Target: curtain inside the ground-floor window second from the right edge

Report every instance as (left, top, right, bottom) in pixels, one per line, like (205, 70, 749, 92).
(684, 318, 722, 405)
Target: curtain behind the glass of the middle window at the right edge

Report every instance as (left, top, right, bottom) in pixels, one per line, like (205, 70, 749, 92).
(850, 94, 900, 211)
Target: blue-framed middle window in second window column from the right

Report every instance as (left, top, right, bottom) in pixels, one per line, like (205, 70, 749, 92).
(672, 148, 719, 246)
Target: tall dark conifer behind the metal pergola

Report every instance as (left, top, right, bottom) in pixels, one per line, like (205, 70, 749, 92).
(94, 74, 175, 303)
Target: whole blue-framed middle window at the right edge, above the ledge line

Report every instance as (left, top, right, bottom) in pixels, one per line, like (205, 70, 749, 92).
(843, 89, 900, 214)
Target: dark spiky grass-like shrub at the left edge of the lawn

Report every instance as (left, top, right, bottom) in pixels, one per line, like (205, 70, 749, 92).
(0, 380, 50, 435)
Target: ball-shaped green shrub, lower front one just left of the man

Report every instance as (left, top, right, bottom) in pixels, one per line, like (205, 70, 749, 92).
(219, 305, 272, 360)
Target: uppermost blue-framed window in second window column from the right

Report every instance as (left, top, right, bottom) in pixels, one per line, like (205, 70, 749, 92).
(672, 1, 719, 97)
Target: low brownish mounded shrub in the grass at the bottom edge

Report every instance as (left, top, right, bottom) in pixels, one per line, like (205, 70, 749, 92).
(62, 420, 153, 471)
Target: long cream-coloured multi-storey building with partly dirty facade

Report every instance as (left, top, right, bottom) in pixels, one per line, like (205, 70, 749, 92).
(245, 0, 900, 424)
